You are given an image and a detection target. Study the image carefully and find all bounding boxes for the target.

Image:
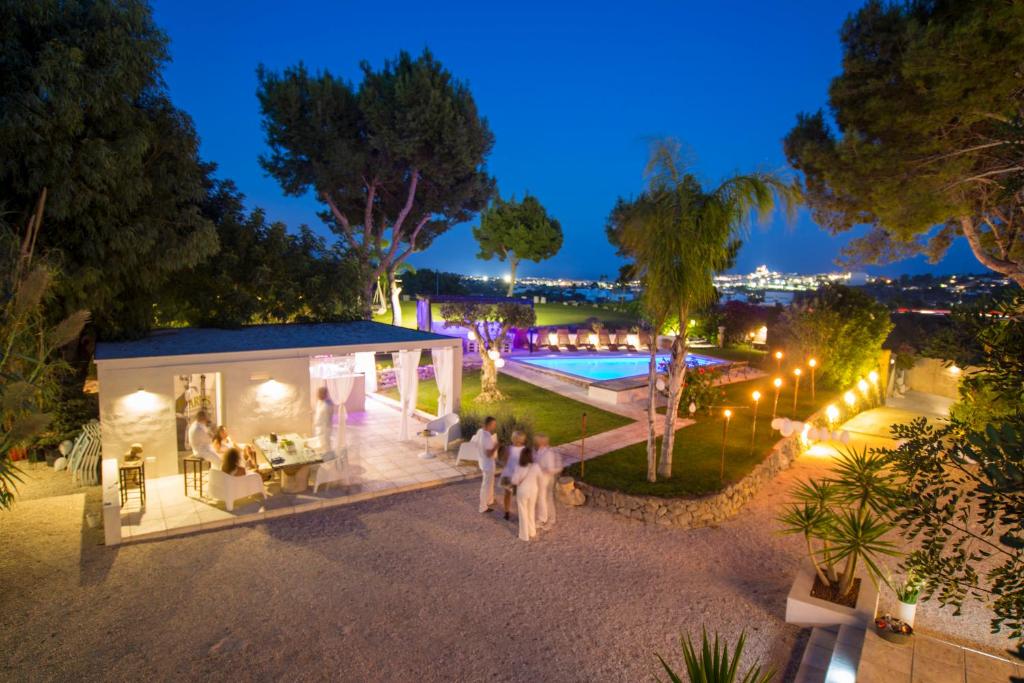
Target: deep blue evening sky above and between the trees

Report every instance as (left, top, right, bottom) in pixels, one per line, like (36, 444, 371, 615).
(149, 0, 983, 278)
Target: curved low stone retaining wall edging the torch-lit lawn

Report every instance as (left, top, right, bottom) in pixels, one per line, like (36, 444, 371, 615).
(577, 434, 803, 528)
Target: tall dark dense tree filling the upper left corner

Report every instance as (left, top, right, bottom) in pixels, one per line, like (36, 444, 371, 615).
(0, 0, 217, 337)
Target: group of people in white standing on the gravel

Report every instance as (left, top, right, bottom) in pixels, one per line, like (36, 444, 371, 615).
(473, 417, 562, 541)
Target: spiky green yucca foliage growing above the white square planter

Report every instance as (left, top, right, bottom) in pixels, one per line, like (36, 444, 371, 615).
(778, 449, 899, 596)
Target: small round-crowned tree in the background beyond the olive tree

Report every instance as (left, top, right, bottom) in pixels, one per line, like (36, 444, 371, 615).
(473, 194, 562, 296)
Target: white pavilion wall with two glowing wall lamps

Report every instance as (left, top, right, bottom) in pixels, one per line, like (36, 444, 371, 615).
(98, 356, 312, 477)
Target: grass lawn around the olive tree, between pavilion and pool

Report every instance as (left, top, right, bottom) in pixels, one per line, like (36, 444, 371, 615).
(381, 371, 632, 444)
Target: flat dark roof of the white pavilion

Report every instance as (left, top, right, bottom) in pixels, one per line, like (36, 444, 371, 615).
(96, 321, 454, 360)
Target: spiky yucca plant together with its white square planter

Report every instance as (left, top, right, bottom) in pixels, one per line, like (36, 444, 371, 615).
(779, 449, 898, 626)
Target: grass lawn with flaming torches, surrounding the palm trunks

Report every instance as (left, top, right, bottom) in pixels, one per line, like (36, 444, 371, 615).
(568, 377, 838, 498)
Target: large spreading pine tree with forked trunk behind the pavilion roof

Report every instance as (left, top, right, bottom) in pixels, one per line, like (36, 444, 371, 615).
(257, 50, 494, 317)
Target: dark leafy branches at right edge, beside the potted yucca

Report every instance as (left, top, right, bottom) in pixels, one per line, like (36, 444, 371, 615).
(880, 295, 1024, 650)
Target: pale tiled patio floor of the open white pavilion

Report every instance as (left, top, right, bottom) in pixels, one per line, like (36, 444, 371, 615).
(121, 397, 479, 543)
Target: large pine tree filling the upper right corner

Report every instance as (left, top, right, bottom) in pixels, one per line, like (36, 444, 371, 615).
(784, 0, 1024, 286)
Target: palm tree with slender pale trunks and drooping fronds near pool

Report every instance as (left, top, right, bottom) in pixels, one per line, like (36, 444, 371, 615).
(608, 140, 798, 481)
